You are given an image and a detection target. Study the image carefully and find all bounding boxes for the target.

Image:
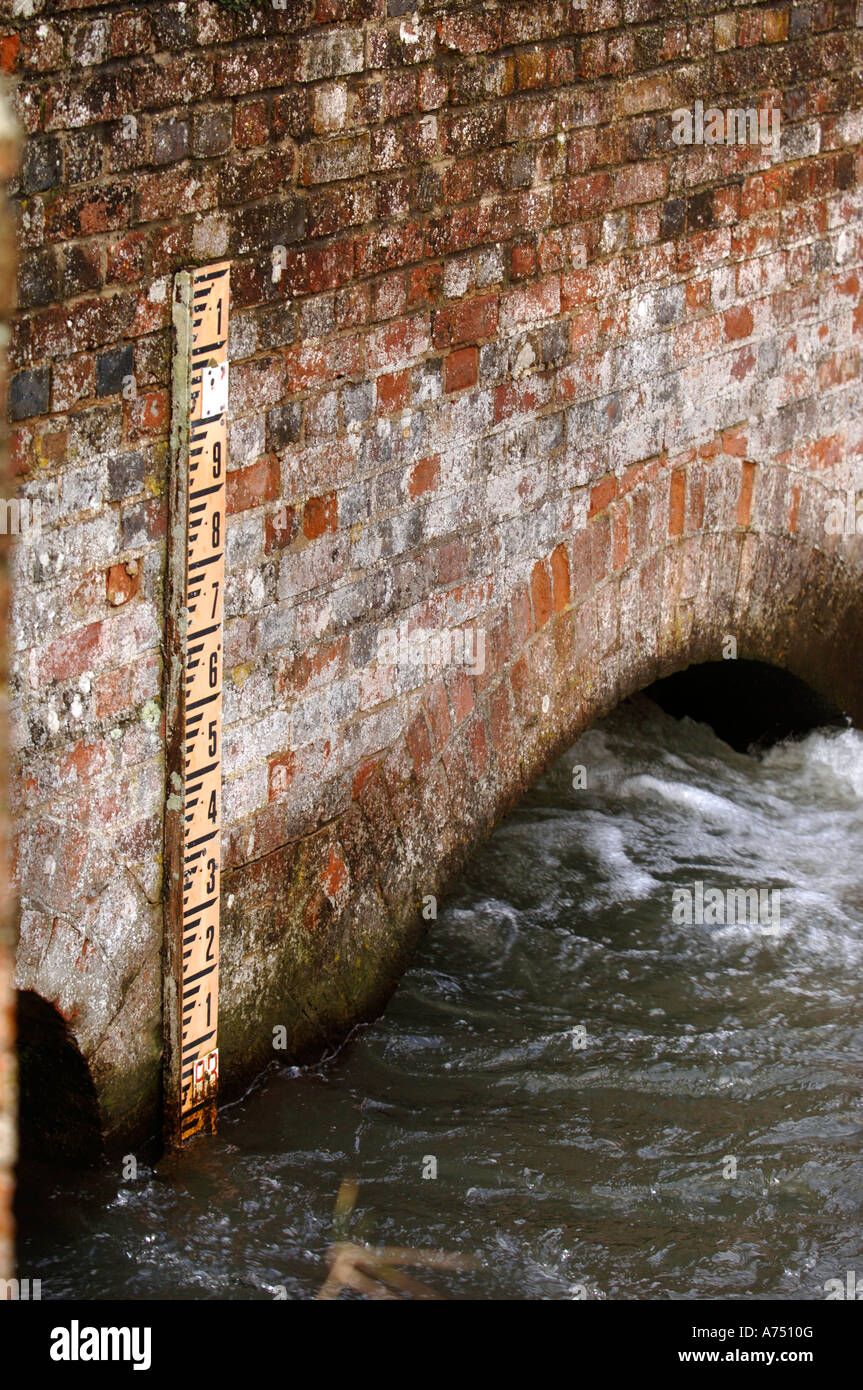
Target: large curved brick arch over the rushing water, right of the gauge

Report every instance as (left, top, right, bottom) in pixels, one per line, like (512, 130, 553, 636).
(216, 461, 863, 1087)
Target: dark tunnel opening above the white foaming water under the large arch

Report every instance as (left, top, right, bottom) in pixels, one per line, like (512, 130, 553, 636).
(643, 660, 848, 753)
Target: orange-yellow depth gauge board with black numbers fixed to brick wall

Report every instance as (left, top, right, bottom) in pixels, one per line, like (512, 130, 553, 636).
(168, 263, 231, 1143)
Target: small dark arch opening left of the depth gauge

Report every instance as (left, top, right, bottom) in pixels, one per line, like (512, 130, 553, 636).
(17, 990, 101, 1176)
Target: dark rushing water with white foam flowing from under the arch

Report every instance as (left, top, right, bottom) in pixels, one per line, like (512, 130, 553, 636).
(19, 701, 863, 1298)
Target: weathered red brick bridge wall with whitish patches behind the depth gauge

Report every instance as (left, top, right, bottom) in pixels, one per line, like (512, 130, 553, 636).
(0, 0, 863, 1131)
